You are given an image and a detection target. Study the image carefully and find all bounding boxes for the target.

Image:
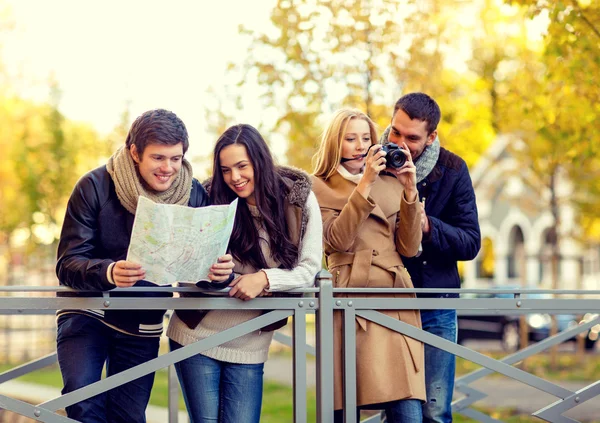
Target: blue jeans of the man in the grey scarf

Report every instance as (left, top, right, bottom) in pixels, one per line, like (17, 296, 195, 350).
(421, 310, 457, 423)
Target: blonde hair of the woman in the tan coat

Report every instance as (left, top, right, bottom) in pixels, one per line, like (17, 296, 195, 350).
(313, 108, 377, 180)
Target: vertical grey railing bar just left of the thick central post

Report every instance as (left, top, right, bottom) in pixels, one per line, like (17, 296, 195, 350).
(293, 308, 307, 423)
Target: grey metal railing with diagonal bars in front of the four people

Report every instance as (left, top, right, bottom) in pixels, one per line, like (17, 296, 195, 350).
(0, 271, 600, 423)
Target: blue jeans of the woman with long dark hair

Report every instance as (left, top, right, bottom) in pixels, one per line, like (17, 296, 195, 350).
(169, 339, 264, 423)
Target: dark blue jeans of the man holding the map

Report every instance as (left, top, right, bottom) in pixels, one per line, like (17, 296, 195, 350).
(56, 314, 159, 423)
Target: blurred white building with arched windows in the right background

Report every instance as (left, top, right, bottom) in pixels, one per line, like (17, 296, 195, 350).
(463, 136, 600, 289)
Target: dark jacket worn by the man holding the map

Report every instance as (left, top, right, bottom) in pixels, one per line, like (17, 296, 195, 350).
(56, 166, 209, 336)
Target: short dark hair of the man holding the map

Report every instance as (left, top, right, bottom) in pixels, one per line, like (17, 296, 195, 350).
(125, 109, 189, 157)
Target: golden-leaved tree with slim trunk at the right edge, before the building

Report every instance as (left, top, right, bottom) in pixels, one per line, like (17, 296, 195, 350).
(502, 0, 600, 362)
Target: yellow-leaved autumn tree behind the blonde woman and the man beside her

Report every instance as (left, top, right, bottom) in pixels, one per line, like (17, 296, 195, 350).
(212, 0, 505, 170)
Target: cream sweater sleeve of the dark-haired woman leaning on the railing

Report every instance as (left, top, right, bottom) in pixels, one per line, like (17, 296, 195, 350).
(262, 192, 323, 292)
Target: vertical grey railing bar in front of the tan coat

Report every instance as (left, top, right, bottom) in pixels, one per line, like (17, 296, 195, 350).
(343, 307, 356, 423)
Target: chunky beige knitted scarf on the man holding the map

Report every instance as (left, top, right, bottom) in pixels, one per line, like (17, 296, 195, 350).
(106, 146, 193, 214)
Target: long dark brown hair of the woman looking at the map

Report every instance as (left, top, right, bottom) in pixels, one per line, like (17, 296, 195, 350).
(210, 124, 299, 270)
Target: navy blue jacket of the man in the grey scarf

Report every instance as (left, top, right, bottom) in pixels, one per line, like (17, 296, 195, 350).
(403, 148, 481, 297)
